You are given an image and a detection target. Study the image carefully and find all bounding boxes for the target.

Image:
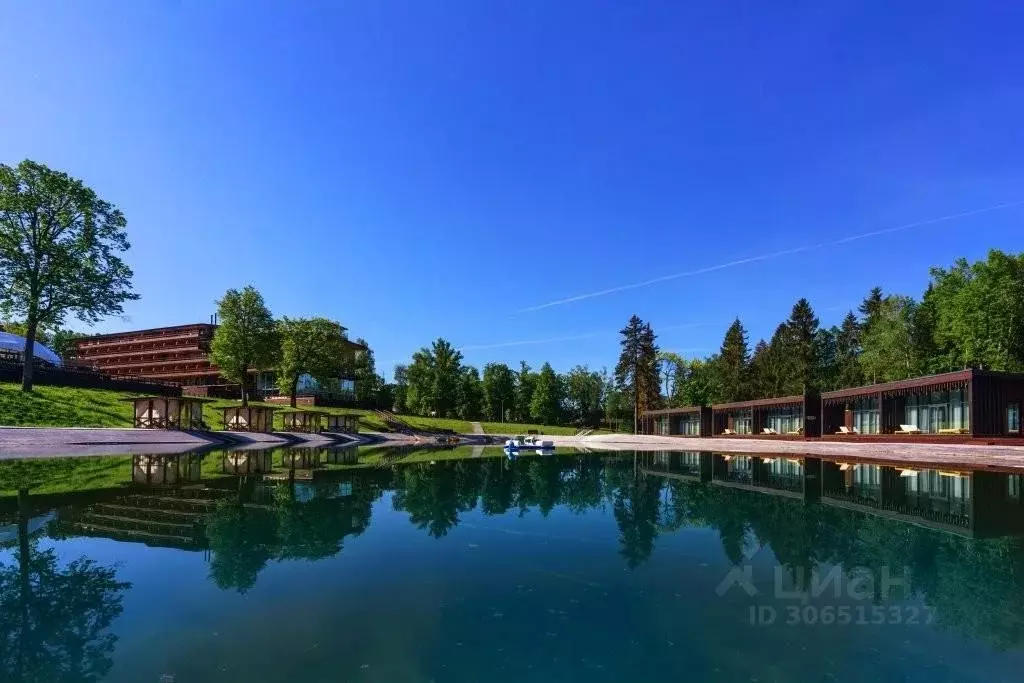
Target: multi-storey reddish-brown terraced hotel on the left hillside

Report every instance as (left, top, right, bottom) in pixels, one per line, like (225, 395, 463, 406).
(68, 323, 366, 399)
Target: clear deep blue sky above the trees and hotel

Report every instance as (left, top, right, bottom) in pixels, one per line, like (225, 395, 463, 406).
(0, 0, 1024, 374)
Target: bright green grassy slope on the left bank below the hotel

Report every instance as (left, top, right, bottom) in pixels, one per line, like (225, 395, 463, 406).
(0, 382, 598, 434)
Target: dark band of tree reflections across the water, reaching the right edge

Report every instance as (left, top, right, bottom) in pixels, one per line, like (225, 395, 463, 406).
(211, 456, 1024, 648)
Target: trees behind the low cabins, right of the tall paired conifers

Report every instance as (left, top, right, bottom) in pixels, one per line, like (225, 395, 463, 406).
(658, 250, 1024, 407)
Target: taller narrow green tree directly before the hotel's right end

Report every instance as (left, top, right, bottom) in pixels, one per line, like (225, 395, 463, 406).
(210, 285, 281, 405)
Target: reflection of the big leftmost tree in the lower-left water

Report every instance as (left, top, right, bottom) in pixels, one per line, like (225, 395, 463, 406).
(0, 493, 131, 683)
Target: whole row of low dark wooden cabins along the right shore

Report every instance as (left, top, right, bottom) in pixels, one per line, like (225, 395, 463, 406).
(641, 370, 1024, 438)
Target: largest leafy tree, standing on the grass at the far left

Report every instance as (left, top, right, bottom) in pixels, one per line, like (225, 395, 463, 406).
(0, 160, 138, 391)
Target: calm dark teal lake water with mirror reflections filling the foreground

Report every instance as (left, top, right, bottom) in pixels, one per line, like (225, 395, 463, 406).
(0, 450, 1024, 683)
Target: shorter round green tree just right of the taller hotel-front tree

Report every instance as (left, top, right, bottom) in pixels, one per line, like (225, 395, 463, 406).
(278, 317, 350, 408)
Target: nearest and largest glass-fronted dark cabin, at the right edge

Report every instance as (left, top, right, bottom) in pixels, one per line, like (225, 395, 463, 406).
(821, 370, 1024, 436)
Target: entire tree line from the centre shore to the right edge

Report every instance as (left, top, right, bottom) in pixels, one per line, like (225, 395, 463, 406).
(393, 250, 1024, 426)
